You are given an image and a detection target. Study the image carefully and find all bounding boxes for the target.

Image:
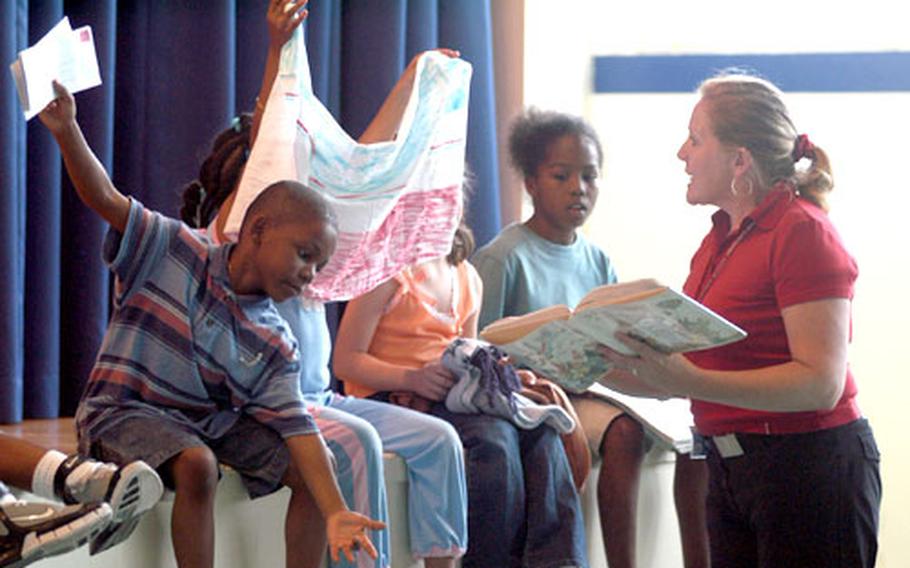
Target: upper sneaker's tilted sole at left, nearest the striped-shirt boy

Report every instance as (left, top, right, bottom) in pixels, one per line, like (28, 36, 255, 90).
(89, 462, 164, 555)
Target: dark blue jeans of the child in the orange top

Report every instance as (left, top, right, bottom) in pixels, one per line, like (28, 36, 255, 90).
(430, 403, 588, 568)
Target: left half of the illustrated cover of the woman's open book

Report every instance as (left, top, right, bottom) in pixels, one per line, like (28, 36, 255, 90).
(500, 321, 612, 392)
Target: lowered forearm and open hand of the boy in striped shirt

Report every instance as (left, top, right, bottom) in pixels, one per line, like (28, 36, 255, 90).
(286, 435, 385, 562)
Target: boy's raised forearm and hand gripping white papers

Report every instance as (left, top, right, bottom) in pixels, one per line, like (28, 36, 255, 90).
(38, 81, 130, 232)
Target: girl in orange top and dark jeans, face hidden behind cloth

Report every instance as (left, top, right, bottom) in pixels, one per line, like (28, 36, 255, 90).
(334, 212, 587, 568)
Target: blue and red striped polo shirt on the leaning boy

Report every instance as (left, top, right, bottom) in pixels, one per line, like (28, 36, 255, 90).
(76, 199, 318, 451)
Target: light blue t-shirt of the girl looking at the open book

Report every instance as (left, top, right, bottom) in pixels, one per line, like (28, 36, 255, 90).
(471, 223, 616, 329)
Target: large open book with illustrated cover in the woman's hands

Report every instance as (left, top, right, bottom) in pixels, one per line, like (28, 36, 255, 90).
(480, 279, 746, 393)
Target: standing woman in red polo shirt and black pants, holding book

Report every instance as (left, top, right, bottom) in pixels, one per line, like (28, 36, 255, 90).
(606, 75, 881, 568)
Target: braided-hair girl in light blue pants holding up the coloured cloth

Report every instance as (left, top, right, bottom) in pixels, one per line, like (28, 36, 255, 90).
(181, 0, 467, 568)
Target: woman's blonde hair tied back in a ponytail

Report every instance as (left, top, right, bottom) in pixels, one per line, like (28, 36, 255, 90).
(698, 71, 834, 211)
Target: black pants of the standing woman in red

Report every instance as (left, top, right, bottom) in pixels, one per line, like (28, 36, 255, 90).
(707, 419, 882, 568)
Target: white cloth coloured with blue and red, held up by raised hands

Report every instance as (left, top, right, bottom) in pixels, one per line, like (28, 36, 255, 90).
(225, 28, 471, 302)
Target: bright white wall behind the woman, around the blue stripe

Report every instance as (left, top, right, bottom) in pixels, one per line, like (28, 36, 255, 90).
(524, 0, 910, 568)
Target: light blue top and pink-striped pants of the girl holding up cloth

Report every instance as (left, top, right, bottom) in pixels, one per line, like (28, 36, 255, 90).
(278, 298, 468, 567)
